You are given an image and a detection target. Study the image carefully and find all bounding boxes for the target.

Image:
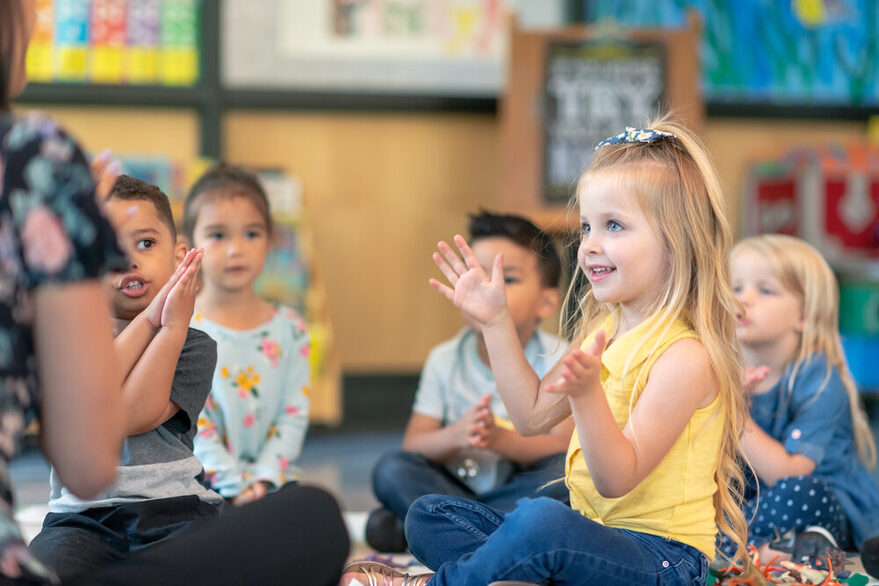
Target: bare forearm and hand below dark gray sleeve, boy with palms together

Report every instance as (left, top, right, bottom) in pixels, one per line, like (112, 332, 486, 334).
(122, 252, 201, 435)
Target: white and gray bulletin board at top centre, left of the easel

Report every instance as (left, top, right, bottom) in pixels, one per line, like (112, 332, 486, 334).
(222, 0, 509, 97)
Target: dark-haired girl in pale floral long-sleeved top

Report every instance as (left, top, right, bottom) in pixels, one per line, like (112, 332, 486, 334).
(183, 164, 310, 505)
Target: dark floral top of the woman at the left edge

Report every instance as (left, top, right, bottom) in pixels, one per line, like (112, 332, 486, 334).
(0, 113, 124, 584)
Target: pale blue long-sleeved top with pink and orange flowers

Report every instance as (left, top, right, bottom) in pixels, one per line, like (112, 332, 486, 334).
(190, 306, 311, 498)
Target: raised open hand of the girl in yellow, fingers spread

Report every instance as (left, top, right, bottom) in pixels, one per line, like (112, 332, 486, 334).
(430, 234, 507, 326)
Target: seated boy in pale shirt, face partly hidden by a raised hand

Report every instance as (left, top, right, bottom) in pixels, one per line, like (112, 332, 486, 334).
(366, 212, 574, 552)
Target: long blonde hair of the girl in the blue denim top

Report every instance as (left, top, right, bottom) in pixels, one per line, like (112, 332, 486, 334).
(732, 234, 876, 468)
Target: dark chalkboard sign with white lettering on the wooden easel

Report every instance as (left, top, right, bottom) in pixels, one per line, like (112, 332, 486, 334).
(543, 42, 665, 203)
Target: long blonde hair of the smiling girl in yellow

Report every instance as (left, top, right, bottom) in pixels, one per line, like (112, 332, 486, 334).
(562, 116, 747, 557)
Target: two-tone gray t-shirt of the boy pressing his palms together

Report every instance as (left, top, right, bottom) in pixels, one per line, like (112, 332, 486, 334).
(49, 328, 223, 513)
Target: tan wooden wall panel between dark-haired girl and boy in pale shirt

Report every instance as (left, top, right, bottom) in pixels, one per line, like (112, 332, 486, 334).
(224, 112, 500, 372)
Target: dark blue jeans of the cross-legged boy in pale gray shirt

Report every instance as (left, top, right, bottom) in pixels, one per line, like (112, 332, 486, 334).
(372, 451, 569, 519)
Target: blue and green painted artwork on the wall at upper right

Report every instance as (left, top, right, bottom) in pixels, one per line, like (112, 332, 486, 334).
(578, 0, 879, 111)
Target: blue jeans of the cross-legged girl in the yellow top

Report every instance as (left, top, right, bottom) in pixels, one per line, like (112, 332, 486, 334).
(406, 495, 708, 586)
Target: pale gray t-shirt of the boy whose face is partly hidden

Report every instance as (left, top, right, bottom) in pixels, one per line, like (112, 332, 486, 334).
(412, 328, 567, 494)
